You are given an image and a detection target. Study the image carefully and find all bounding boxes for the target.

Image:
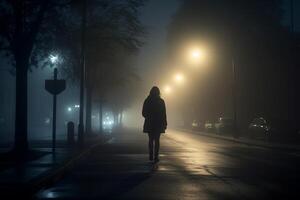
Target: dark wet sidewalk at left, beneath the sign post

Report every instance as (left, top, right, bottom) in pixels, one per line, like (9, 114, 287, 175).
(0, 136, 108, 197)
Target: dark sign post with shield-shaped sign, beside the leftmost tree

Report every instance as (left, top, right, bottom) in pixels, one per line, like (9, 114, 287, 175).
(45, 68, 66, 153)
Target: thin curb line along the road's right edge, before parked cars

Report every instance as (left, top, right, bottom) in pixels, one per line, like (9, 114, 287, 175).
(174, 128, 300, 151)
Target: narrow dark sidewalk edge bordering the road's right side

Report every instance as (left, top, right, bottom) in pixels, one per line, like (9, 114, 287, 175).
(175, 128, 300, 151)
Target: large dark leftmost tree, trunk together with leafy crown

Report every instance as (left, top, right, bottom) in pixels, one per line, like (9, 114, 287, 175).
(0, 0, 76, 152)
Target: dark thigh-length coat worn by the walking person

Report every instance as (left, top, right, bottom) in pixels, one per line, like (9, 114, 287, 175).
(142, 96, 167, 133)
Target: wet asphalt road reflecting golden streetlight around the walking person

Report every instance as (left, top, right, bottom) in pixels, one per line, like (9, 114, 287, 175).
(35, 130, 300, 200)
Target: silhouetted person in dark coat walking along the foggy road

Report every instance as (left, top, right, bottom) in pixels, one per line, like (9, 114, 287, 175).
(142, 86, 167, 162)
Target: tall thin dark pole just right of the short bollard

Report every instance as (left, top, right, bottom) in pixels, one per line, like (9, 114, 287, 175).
(78, 0, 87, 146)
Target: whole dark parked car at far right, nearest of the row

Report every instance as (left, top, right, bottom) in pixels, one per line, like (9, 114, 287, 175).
(249, 117, 297, 142)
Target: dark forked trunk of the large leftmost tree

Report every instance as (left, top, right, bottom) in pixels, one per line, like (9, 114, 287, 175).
(11, 1, 50, 153)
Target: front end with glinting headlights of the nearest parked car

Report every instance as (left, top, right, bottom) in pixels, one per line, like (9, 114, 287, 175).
(248, 117, 270, 140)
